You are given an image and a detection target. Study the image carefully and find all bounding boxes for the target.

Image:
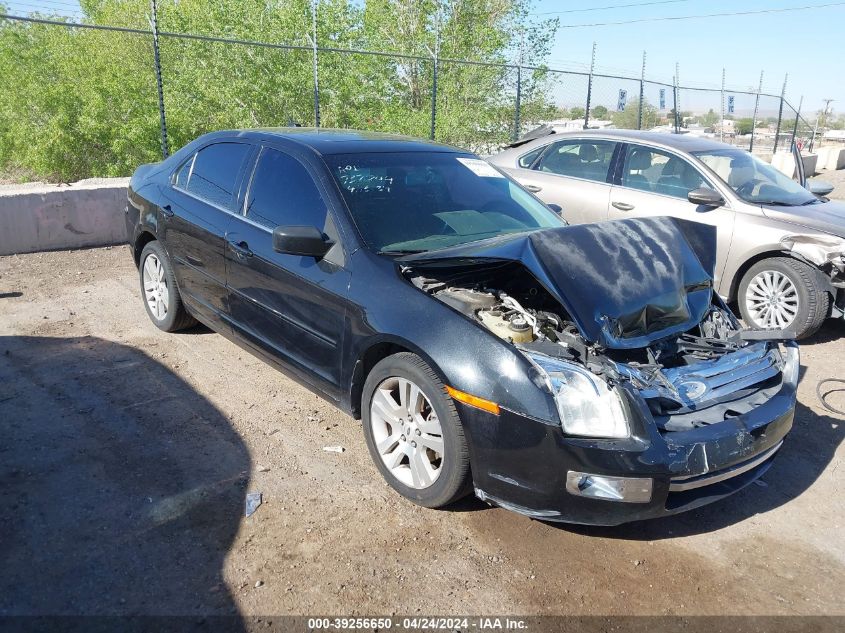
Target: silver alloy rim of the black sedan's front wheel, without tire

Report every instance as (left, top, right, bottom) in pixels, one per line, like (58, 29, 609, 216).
(370, 376, 443, 490)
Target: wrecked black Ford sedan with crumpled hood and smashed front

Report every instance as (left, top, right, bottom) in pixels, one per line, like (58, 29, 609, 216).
(126, 128, 798, 525)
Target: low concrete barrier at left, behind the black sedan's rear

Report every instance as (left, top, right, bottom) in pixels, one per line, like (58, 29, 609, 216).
(0, 178, 129, 255)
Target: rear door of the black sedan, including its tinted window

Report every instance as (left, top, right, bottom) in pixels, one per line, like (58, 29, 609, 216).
(160, 141, 252, 325)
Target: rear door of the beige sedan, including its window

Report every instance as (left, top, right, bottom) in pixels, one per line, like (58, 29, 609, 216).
(504, 139, 618, 224)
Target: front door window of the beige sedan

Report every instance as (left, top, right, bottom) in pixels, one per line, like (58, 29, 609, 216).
(620, 145, 709, 200)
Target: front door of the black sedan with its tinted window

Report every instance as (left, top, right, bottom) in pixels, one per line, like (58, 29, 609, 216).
(226, 147, 349, 399)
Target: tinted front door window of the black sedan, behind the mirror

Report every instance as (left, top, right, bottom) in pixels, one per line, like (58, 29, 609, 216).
(246, 147, 326, 230)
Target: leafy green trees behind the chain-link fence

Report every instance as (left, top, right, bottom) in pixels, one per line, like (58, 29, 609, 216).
(0, 0, 568, 180)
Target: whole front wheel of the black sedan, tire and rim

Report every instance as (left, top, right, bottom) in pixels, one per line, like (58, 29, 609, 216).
(361, 352, 472, 508)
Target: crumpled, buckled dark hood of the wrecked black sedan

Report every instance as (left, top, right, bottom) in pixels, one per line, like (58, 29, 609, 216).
(397, 217, 716, 349)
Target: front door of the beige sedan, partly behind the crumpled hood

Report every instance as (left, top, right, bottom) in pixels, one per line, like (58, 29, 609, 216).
(608, 143, 735, 288)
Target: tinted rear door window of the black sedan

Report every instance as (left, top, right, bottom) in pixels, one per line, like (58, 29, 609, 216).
(183, 143, 250, 210)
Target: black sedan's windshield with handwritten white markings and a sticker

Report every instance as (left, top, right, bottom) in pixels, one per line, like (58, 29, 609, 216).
(325, 152, 566, 253)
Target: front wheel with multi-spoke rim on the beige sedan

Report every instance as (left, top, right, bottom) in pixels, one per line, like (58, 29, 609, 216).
(737, 257, 830, 339)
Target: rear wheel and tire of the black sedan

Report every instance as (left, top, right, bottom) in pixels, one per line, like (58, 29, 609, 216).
(138, 241, 197, 332)
